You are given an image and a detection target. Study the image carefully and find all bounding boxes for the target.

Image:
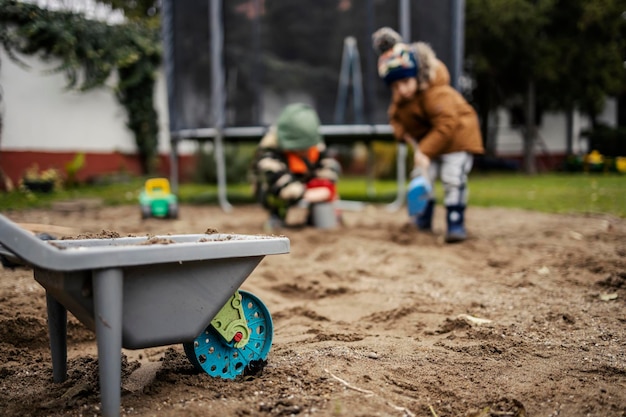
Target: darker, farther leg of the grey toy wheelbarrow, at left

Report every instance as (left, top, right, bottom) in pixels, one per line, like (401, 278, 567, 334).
(46, 291, 67, 382)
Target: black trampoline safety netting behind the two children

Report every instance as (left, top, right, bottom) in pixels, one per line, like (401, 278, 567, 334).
(163, 0, 452, 130)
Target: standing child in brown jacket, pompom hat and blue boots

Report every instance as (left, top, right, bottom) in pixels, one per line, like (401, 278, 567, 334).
(372, 27, 484, 243)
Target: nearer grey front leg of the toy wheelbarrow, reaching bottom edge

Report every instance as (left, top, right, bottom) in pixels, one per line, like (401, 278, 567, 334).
(92, 268, 124, 417)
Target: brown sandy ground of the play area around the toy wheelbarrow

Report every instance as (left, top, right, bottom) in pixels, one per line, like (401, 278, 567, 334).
(0, 205, 626, 417)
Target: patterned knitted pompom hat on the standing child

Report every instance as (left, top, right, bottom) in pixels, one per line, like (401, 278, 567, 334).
(372, 27, 419, 85)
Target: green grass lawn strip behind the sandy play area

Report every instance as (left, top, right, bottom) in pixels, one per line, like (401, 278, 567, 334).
(0, 173, 626, 218)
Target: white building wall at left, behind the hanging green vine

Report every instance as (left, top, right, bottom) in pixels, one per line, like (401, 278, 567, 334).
(0, 48, 169, 153)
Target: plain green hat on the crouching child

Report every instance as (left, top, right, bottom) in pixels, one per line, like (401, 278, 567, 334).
(276, 103, 322, 150)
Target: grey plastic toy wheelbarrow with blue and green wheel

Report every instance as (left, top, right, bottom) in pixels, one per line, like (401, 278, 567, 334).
(0, 215, 289, 416)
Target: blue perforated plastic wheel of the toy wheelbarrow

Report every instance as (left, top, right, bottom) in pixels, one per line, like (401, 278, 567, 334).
(183, 290, 274, 379)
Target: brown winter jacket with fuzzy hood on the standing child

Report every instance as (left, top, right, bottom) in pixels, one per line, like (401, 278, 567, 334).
(388, 42, 484, 159)
